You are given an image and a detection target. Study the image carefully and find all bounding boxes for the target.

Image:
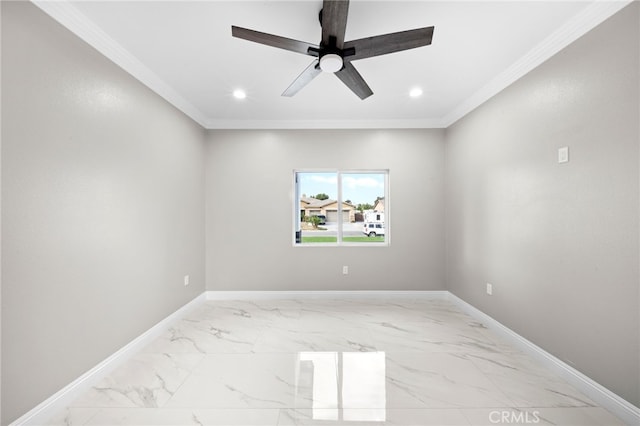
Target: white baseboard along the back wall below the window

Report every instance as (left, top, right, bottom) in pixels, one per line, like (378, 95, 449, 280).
(206, 290, 449, 300)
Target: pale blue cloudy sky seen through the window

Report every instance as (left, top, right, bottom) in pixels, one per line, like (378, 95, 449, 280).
(298, 172, 385, 206)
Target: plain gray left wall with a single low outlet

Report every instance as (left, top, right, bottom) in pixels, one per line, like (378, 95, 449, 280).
(2, 2, 205, 424)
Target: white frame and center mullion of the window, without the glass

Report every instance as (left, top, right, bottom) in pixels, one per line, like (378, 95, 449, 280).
(291, 169, 391, 247)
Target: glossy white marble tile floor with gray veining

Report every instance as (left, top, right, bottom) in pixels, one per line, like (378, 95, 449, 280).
(49, 299, 624, 426)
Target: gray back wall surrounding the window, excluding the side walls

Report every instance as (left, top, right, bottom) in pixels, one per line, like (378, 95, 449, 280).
(206, 130, 445, 290)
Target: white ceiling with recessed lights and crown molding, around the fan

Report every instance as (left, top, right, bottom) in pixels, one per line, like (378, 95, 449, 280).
(35, 0, 629, 128)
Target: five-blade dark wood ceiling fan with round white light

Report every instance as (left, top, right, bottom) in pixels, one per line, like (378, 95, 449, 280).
(231, 0, 434, 99)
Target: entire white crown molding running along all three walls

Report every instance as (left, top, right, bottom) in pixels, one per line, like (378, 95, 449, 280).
(31, 0, 633, 129)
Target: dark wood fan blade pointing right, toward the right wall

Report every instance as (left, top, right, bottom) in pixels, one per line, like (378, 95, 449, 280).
(344, 27, 434, 61)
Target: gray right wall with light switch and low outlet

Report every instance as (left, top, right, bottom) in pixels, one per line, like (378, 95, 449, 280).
(446, 2, 640, 406)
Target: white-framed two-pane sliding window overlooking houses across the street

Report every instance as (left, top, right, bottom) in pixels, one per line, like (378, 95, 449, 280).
(294, 170, 389, 246)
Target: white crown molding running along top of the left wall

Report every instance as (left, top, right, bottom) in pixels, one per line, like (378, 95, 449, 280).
(31, 0, 206, 127)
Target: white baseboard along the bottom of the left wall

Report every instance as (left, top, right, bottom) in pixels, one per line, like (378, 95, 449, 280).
(9, 293, 206, 426)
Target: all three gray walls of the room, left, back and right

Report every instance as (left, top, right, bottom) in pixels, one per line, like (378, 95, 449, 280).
(1, 2, 640, 424)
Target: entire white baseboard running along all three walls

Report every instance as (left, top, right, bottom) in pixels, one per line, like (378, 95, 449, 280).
(11, 290, 640, 426)
